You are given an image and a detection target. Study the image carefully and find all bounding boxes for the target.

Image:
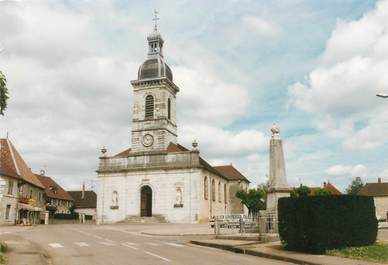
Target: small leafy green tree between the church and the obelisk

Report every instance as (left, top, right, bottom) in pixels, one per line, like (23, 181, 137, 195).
(236, 188, 266, 215)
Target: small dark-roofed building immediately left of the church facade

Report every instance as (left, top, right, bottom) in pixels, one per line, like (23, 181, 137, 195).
(68, 186, 97, 220)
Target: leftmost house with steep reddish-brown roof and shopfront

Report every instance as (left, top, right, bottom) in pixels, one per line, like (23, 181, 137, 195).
(0, 138, 45, 225)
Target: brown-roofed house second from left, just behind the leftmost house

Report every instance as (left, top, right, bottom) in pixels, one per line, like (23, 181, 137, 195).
(35, 171, 74, 216)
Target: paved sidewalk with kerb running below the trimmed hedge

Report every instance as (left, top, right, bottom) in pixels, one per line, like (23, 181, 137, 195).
(190, 239, 381, 265)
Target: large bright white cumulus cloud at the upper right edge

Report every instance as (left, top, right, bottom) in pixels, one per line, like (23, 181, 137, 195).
(289, 1, 388, 150)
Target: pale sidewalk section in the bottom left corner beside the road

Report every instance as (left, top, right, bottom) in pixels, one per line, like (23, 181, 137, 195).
(0, 234, 50, 265)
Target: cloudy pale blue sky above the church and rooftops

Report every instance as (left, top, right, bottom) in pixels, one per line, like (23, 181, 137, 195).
(0, 0, 388, 191)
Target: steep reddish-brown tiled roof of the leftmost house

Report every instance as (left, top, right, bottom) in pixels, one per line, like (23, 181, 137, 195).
(0, 139, 44, 189)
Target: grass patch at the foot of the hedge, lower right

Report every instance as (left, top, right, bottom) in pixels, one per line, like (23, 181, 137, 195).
(326, 242, 388, 264)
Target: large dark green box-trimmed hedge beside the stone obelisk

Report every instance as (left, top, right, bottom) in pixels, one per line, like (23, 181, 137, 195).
(278, 195, 377, 254)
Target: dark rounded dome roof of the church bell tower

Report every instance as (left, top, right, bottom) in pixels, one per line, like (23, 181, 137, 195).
(137, 57, 172, 82)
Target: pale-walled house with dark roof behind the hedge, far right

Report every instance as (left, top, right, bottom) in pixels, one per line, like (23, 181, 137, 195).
(358, 178, 388, 220)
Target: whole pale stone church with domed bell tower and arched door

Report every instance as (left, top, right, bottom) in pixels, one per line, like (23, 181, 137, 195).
(97, 21, 249, 224)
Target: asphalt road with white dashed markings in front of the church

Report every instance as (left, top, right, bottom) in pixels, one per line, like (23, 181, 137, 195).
(0, 225, 290, 265)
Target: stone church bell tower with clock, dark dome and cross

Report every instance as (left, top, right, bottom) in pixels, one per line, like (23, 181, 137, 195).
(131, 12, 179, 152)
